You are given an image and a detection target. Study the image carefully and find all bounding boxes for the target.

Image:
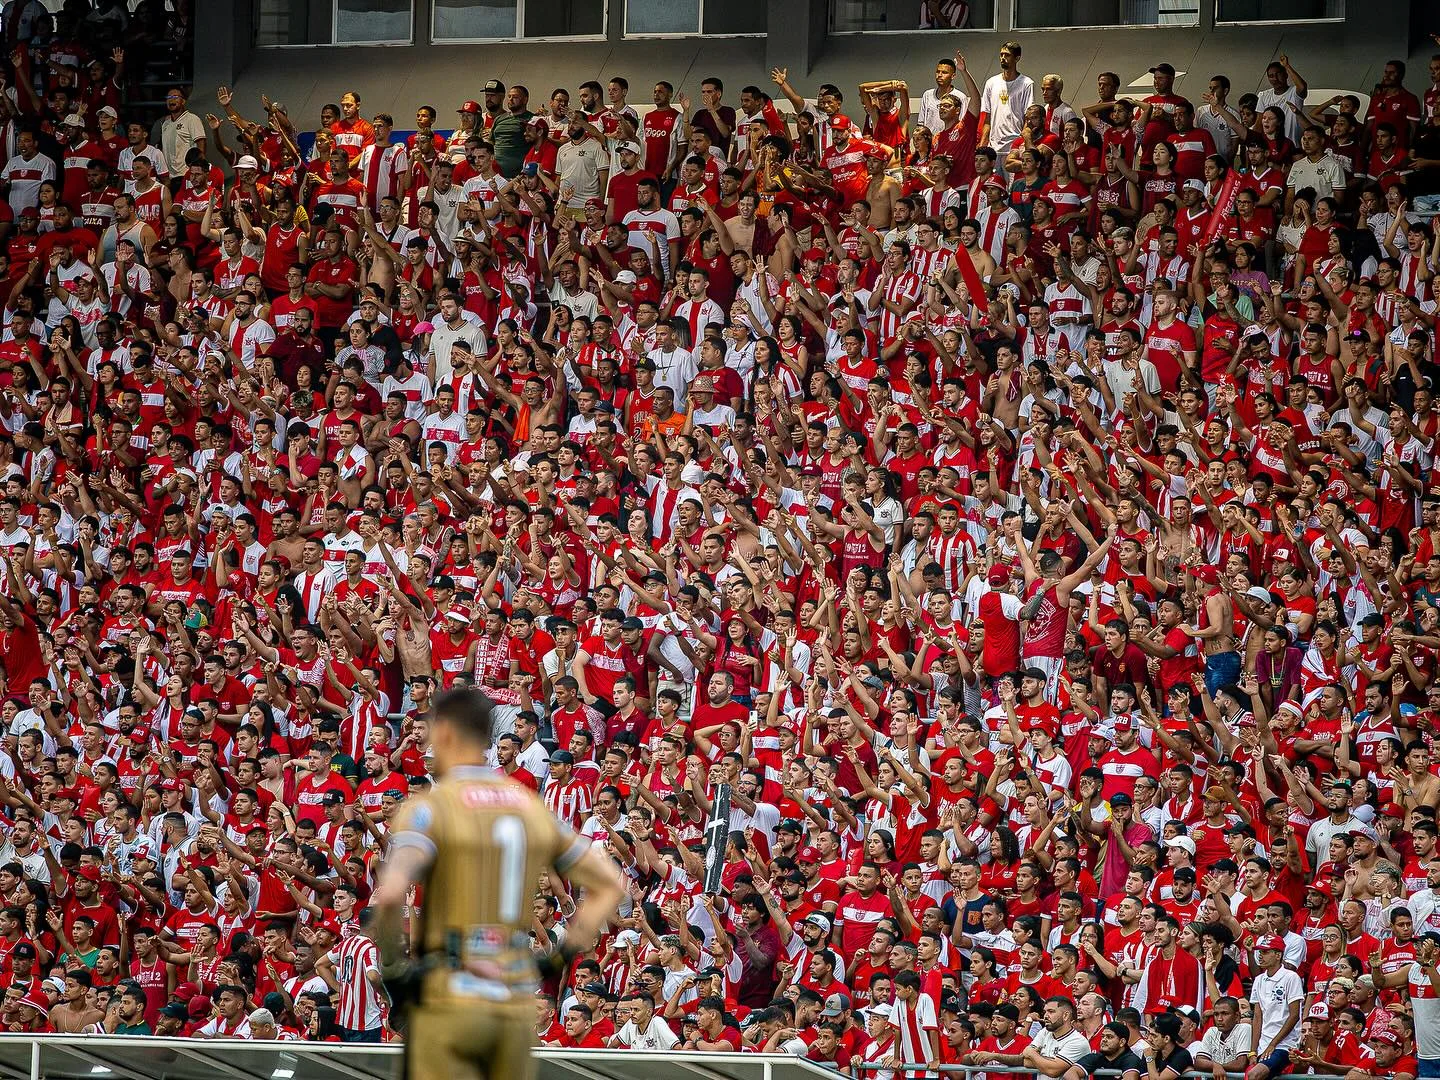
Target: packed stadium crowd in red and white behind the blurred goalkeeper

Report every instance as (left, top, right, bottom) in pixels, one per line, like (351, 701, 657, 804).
(0, 3, 1440, 1080)
